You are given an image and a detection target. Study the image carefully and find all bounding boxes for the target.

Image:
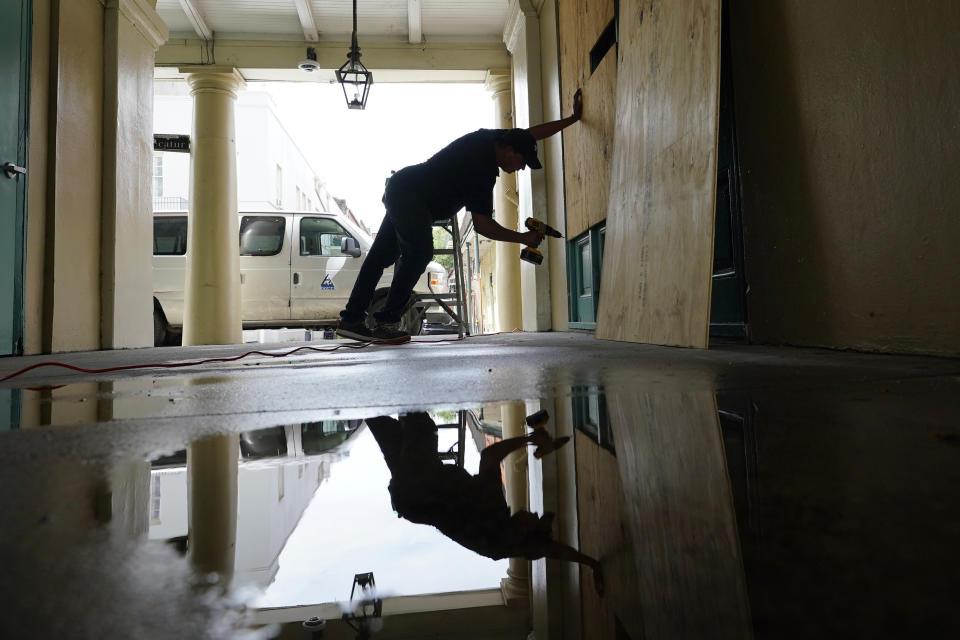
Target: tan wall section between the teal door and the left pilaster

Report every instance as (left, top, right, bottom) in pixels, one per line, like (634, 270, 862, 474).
(24, 0, 103, 353)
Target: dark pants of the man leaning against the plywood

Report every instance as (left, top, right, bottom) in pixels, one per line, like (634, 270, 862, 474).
(340, 185, 433, 322)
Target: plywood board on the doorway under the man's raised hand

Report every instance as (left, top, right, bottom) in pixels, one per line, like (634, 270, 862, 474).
(557, 0, 617, 238)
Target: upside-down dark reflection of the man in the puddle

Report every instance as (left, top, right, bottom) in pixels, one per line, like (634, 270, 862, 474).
(367, 413, 603, 591)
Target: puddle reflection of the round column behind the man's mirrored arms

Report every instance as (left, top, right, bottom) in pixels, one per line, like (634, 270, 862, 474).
(500, 402, 530, 606)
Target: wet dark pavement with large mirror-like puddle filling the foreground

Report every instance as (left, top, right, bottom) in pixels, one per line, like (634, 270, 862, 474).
(0, 334, 960, 640)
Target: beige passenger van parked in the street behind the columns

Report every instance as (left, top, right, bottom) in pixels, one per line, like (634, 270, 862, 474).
(153, 211, 447, 345)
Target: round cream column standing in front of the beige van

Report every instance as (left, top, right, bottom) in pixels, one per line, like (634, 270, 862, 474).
(181, 67, 243, 345)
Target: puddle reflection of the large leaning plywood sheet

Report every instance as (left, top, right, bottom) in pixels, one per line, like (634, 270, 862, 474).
(608, 387, 752, 639)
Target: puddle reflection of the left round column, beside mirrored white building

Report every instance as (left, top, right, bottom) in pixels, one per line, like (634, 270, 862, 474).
(187, 434, 240, 585)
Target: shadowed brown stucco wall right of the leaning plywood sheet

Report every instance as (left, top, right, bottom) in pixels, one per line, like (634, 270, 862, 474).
(729, 0, 960, 355)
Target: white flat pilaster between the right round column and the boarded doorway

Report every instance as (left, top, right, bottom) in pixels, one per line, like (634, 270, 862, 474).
(503, 0, 552, 331)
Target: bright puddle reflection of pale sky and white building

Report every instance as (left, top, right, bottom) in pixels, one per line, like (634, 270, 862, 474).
(150, 413, 506, 607)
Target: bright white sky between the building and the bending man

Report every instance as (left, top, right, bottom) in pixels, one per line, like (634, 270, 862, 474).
(247, 82, 494, 231)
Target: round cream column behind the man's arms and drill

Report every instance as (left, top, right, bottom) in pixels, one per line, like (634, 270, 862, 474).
(486, 70, 523, 331)
